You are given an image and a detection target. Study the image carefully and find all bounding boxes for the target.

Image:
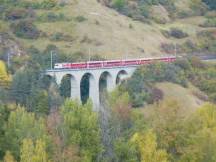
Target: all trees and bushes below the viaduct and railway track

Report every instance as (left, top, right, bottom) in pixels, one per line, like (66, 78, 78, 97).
(0, 51, 216, 162)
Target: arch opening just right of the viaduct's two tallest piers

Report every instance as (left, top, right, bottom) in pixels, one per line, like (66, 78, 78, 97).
(99, 71, 113, 103)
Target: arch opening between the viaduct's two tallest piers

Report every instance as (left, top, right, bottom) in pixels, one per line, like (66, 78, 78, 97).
(80, 73, 95, 104)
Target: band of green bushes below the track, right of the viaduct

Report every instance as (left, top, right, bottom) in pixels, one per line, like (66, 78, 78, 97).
(120, 57, 216, 107)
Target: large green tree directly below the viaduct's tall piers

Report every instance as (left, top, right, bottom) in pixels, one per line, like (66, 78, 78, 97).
(61, 100, 102, 161)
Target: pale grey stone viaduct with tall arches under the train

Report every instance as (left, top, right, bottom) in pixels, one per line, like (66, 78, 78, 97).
(45, 66, 137, 111)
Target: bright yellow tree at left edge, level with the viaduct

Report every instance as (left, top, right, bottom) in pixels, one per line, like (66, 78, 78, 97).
(0, 60, 11, 87)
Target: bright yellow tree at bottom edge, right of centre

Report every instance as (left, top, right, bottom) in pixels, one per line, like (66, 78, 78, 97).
(131, 131, 168, 162)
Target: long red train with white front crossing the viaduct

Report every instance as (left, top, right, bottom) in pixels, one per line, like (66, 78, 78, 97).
(54, 56, 176, 69)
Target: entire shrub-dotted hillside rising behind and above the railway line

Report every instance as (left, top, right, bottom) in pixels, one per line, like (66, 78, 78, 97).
(0, 0, 216, 58)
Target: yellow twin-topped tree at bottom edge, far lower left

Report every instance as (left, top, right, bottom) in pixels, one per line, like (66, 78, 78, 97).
(20, 139, 50, 162)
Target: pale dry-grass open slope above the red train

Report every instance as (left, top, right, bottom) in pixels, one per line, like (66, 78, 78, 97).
(0, 0, 214, 58)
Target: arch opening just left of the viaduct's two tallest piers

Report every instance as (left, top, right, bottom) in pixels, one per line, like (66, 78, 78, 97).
(60, 74, 79, 99)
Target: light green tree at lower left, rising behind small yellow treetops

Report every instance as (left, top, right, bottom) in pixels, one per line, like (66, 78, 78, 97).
(4, 107, 49, 159)
